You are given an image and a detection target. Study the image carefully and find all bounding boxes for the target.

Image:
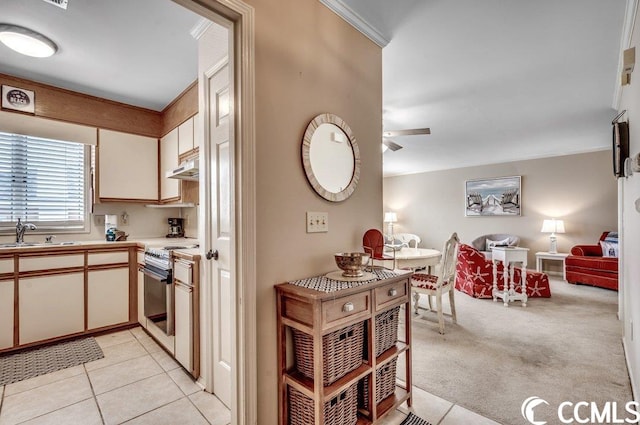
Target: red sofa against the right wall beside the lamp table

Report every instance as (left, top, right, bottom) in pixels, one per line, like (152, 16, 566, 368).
(565, 232, 618, 291)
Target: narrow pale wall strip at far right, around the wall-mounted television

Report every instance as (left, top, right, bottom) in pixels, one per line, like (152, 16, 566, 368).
(620, 4, 640, 400)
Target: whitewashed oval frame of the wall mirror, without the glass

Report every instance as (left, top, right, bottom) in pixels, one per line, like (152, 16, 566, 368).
(302, 113, 360, 202)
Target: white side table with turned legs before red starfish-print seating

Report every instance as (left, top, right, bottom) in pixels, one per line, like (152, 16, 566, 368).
(491, 247, 529, 307)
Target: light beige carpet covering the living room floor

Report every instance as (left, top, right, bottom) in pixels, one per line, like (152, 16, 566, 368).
(398, 279, 632, 424)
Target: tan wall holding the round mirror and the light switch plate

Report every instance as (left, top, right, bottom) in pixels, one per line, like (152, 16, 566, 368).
(247, 0, 382, 425)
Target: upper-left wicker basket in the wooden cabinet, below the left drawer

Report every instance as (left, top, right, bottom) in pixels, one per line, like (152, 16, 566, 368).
(291, 322, 364, 386)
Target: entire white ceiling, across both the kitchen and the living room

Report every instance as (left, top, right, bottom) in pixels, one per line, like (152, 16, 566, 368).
(0, 0, 626, 176)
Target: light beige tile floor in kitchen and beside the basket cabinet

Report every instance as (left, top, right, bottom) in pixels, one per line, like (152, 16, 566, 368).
(0, 328, 499, 425)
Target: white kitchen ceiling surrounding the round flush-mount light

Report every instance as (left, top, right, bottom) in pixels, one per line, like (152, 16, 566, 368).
(0, 0, 201, 111)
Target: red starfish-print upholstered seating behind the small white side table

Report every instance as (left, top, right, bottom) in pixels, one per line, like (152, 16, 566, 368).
(456, 244, 551, 298)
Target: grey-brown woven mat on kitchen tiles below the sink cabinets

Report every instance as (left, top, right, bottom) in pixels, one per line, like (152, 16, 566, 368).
(0, 338, 104, 386)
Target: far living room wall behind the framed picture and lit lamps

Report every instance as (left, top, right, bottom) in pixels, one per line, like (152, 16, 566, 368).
(384, 151, 617, 268)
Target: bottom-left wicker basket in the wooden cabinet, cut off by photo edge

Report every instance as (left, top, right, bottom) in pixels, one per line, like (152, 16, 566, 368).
(289, 382, 358, 425)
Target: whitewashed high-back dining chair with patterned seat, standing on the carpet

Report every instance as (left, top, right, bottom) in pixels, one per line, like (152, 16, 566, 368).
(411, 232, 460, 334)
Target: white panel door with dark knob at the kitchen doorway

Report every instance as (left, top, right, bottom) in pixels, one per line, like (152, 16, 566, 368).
(207, 60, 235, 406)
